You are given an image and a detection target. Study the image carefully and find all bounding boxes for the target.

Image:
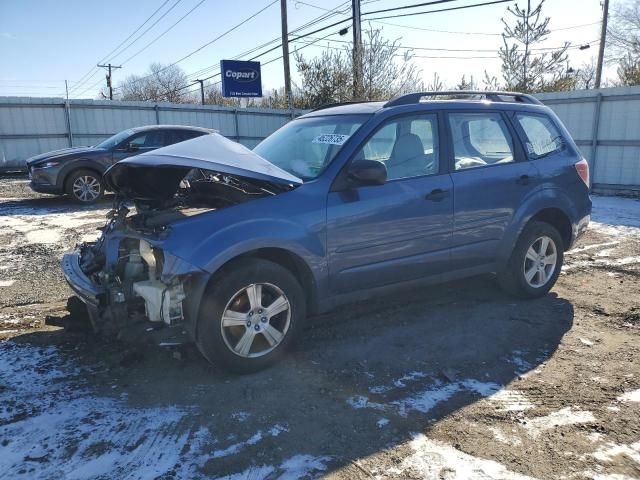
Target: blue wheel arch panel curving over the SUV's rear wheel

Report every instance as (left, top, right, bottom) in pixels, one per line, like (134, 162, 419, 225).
(497, 186, 578, 265)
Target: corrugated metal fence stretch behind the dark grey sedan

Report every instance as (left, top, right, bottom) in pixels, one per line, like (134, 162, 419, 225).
(0, 97, 302, 170)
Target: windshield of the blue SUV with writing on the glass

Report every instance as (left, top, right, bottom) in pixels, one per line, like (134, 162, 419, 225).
(253, 115, 369, 180)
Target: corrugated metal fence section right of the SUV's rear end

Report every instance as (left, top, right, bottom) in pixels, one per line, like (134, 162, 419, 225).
(536, 87, 640, 194)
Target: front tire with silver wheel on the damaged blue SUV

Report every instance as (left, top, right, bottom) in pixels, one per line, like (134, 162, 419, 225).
(196, 258, 306, 373)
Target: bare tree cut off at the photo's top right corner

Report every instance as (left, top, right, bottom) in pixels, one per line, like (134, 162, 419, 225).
(607, 0, 640, 62)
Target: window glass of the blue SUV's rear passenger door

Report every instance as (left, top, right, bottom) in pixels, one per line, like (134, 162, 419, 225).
(448, 112, 514, 170)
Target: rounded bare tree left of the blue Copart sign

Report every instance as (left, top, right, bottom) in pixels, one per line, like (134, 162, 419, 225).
(117, 63, 191, 103)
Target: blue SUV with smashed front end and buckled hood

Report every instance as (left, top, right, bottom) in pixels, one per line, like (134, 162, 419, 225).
(62, 91, 591, 372)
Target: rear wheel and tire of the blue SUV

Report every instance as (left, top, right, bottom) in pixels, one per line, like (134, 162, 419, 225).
(498, 221, 564, 298)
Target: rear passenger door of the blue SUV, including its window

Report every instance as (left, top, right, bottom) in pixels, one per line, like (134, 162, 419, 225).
(447, 110, 539, 269)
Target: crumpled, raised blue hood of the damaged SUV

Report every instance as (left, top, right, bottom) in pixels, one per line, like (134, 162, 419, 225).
(104, 133, 302, 199)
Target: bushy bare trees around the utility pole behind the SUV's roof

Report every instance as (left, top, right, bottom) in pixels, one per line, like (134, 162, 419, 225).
(294, 27, 420, 107)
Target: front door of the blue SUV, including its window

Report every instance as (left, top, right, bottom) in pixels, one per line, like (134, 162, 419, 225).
(327, 113, 453, 293)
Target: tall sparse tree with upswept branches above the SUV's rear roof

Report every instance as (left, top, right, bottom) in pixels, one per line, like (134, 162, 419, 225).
(498, 0, 570, 92)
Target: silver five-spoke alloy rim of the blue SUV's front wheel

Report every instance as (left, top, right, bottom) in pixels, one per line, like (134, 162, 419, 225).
(220, 283, 291, 358)
